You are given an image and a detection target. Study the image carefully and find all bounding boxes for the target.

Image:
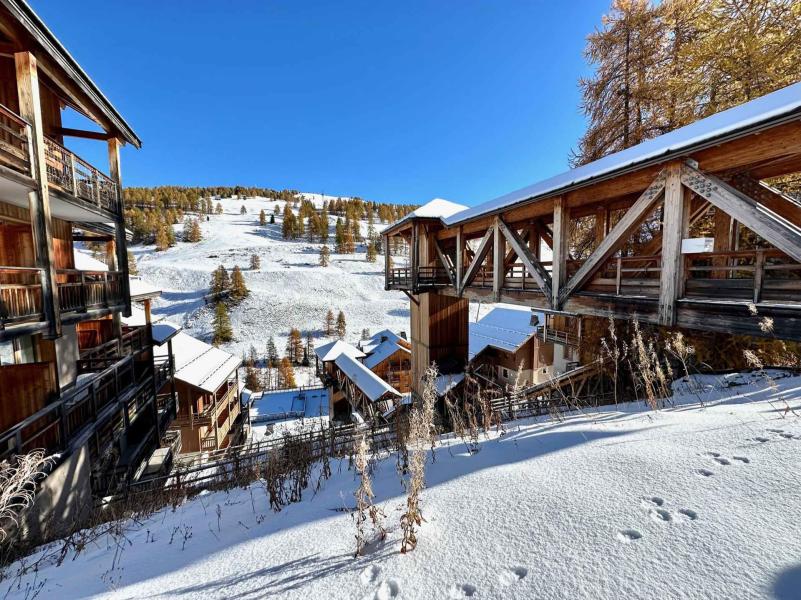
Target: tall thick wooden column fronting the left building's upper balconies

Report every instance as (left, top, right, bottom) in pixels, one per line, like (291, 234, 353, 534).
(14, 52, 61, 339)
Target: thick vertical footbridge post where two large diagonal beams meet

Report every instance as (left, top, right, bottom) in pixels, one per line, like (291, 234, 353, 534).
(659, 163, 688, 327)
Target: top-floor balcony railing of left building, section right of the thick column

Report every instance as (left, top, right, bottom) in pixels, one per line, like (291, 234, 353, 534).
(45, 137, 120, 214)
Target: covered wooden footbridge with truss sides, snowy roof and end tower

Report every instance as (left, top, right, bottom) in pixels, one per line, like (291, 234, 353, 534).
(382, 83, 801, 396)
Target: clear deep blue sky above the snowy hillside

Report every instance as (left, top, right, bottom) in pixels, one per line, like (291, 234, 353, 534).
(31, 0, 609, 204)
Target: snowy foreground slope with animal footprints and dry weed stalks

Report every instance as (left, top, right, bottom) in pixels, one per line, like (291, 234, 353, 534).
(6, 375, 801, 600)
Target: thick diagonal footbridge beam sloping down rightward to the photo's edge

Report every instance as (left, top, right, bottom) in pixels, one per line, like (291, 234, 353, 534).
(681, 165, 801, 262)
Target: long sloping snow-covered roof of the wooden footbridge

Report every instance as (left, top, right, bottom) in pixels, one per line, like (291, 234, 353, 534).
(428, 82, 801, 226)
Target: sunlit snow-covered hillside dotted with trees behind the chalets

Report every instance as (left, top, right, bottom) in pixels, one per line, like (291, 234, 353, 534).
(131, 194, 409, 364)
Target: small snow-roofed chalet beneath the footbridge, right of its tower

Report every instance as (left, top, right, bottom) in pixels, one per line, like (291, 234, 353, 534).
(469, 305, 576, 386)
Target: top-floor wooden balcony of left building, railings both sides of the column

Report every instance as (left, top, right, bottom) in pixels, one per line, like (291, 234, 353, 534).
(0, 105, 123, 215)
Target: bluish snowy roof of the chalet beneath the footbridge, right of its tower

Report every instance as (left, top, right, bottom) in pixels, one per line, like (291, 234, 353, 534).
(468, 306, 537, 358)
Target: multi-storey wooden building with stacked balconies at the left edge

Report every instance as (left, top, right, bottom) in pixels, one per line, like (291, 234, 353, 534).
(0, 0, 171, 536)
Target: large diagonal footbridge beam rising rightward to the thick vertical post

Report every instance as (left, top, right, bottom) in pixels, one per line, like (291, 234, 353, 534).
(554, 171, 665, 308)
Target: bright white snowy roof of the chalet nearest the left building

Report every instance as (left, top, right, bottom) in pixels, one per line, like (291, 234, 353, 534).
(153, 332, 242, 393)
